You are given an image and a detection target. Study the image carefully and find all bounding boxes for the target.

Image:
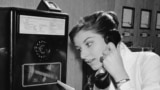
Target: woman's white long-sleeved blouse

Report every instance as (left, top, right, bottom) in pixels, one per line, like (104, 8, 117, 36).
(94, 43, 160, 90)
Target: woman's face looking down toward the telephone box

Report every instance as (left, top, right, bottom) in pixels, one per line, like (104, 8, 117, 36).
(74, 30, 107, 70)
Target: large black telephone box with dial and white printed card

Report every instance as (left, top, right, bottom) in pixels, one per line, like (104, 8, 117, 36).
(0, 7, 69, 90)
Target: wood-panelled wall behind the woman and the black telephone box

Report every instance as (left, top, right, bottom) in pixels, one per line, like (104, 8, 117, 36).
(0, 0, 160, 90)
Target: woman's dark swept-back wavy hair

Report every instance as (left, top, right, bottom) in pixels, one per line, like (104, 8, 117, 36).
(69, 11, 121, 45)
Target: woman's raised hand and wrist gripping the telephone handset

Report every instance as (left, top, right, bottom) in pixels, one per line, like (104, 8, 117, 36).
(102, 42, 128, 82)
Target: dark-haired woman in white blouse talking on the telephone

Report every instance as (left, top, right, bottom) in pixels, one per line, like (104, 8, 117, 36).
(58, 11, 160, 90)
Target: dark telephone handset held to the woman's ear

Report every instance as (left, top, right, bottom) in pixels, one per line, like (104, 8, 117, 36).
(94, 31, 121, 89)
